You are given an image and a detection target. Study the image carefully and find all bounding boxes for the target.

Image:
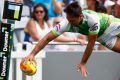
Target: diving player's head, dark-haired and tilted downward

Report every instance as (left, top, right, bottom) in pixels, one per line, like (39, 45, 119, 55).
(64, 1, 83, 25)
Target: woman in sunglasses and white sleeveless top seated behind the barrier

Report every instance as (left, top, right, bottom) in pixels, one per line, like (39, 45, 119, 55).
(25, 4, 50, 41)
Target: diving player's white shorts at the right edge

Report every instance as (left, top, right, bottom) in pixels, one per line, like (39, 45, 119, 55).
(97, 22, 120, 49)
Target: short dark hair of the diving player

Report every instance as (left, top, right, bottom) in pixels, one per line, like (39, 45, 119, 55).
(64, 1, 82, 17)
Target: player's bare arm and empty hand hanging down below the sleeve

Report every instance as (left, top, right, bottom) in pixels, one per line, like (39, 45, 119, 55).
(78, 35, 97, 77)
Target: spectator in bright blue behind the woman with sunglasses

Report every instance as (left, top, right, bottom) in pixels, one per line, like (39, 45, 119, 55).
(33, 0, 63, 26)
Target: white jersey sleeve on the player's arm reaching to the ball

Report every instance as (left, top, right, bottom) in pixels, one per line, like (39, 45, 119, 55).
(52, 19, 69, 36)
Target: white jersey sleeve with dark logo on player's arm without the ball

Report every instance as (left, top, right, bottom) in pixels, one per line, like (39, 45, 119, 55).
(83, 10, 100, 35)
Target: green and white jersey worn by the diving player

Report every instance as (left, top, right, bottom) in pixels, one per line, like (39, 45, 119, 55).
(52, 10, 115, 36)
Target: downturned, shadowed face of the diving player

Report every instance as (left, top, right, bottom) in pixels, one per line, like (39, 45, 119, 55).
(67, 14, 83, 26)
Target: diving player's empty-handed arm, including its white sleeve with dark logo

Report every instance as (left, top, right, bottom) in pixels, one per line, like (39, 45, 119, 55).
(78, 11, 100, 77)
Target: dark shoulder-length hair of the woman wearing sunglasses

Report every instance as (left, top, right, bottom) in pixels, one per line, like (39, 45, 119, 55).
(32, 3, 49, 21)
